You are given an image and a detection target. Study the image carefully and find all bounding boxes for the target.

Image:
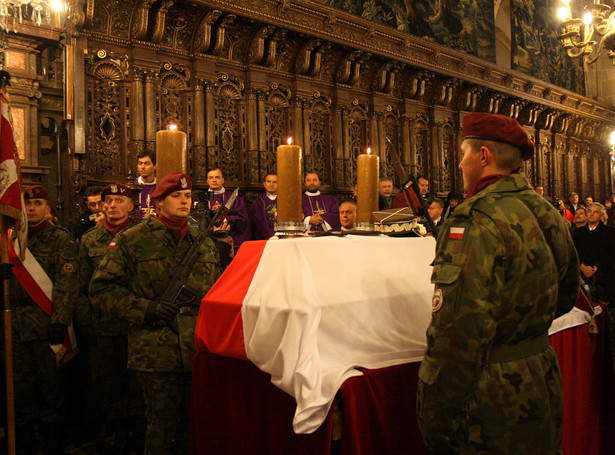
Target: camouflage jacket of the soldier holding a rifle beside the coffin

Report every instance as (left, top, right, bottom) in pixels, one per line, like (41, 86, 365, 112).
(90, 217, 220, 372)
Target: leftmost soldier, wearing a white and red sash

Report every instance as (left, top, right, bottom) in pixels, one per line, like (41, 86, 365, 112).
(10, 185, 77, 455)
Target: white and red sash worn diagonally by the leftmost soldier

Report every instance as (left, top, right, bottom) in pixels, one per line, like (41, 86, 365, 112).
(9, 232, 77, 362)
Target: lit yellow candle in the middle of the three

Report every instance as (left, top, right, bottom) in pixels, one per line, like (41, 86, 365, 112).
(277, 138, 303, 222)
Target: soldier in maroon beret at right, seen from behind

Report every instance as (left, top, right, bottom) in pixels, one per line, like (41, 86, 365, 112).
(417, 113, 579, 455)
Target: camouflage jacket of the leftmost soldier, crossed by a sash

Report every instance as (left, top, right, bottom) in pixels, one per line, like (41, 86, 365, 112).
(10, 223, 78, 341)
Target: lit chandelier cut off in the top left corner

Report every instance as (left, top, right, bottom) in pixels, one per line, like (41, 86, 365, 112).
(0, 0, 63, 32)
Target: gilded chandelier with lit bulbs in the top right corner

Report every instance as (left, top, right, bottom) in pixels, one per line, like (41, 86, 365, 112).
(558, 0, 615, 64)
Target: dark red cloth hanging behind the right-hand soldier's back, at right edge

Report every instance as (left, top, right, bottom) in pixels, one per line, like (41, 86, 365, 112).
(549, 302, 615, 455)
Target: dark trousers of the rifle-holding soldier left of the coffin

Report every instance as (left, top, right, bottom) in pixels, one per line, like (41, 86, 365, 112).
(137, 371, 191, 455)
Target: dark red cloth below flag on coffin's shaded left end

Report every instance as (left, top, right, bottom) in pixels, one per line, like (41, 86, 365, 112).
(190, 348, 331, 455)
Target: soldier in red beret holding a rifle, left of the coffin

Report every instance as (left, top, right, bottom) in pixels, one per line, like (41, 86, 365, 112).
(90, 173, 220, 455)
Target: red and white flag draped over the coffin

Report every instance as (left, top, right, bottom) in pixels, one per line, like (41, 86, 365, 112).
(196, 236, 435, 433)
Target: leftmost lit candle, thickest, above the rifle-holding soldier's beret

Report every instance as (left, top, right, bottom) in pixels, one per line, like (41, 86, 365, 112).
(156, 125, 188, 180)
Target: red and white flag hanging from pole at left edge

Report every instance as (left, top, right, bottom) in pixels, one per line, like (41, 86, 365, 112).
(0, 88, 28, 259)
